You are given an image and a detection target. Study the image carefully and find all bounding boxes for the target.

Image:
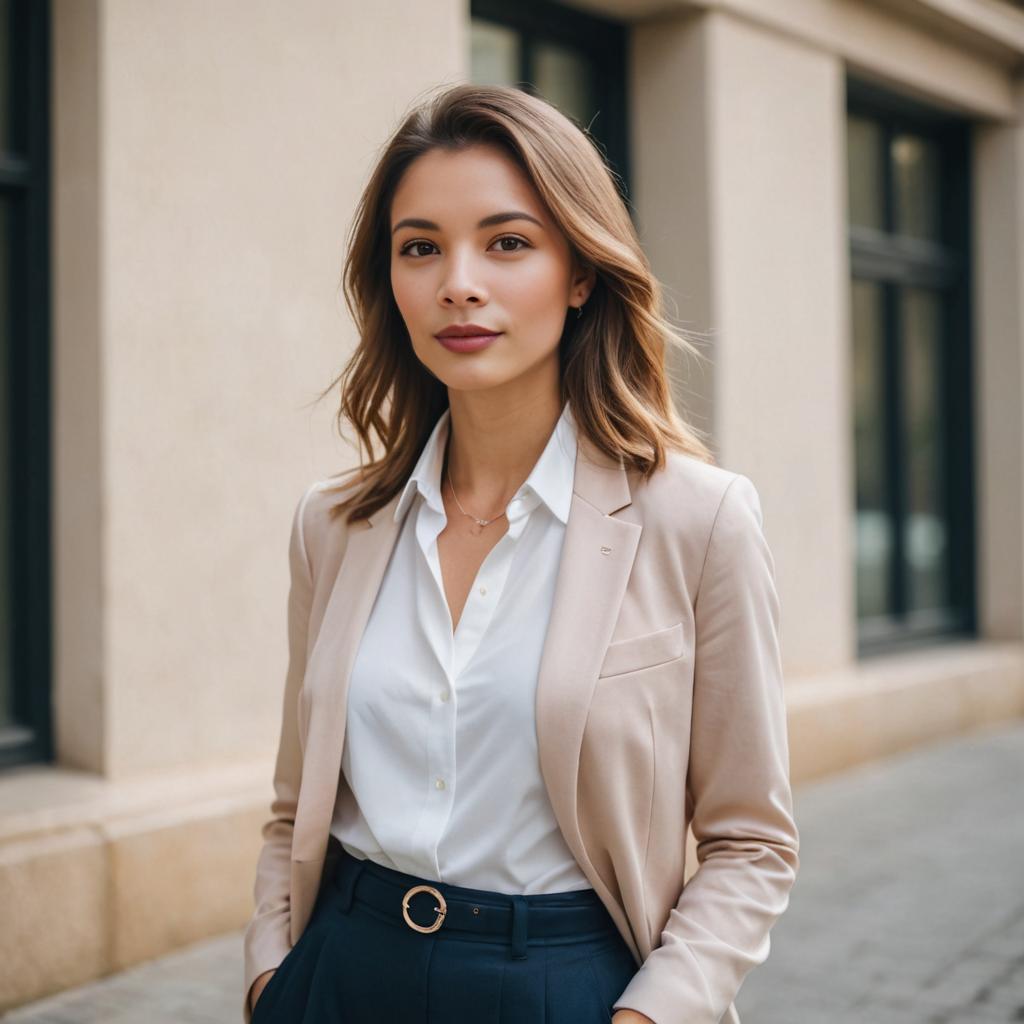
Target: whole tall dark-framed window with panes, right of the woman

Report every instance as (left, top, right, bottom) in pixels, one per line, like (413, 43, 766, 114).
(847, 82, 976, 653)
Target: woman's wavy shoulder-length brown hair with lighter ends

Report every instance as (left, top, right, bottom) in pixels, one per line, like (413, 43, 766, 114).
(317, 84, 713, 522)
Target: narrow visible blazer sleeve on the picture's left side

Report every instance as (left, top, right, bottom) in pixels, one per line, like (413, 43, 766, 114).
(243, 487, 313, 1024)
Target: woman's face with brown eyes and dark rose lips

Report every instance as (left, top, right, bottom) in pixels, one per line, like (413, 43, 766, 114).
(390, 144, 593, 399)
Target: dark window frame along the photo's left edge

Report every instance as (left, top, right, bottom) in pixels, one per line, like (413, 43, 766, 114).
(0, 0, 53, 767)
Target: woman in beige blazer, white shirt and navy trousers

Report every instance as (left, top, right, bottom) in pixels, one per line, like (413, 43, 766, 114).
(245, 85, 799, 1024)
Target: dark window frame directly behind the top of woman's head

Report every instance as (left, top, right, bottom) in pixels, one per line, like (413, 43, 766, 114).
(470, 0, 633, 205)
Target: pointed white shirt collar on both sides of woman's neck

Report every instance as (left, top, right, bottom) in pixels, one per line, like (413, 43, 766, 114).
(394, 402, 578, 523)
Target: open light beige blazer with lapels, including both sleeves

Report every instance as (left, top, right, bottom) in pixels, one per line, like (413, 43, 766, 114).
(244, 434, 799, 1024)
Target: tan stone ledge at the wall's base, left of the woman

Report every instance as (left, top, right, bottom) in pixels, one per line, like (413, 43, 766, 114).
(0, 760, 273, 1013)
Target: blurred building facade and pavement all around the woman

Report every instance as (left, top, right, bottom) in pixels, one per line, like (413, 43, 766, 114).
(0, 0, 1024, 1024)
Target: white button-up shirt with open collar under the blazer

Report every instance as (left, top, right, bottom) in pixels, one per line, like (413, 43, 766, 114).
(331, 404, 590, 895)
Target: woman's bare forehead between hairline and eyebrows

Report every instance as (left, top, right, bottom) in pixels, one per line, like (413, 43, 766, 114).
(391, 144, 549, 224)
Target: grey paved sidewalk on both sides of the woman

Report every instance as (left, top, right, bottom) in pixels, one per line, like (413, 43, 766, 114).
(3, 722, 1024, 1024)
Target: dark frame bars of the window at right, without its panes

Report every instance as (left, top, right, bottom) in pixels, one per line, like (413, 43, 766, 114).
(847, 78, 977, 656)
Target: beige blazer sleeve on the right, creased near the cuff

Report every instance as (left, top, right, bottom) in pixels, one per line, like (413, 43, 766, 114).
(615, 474, 800, 1024)
